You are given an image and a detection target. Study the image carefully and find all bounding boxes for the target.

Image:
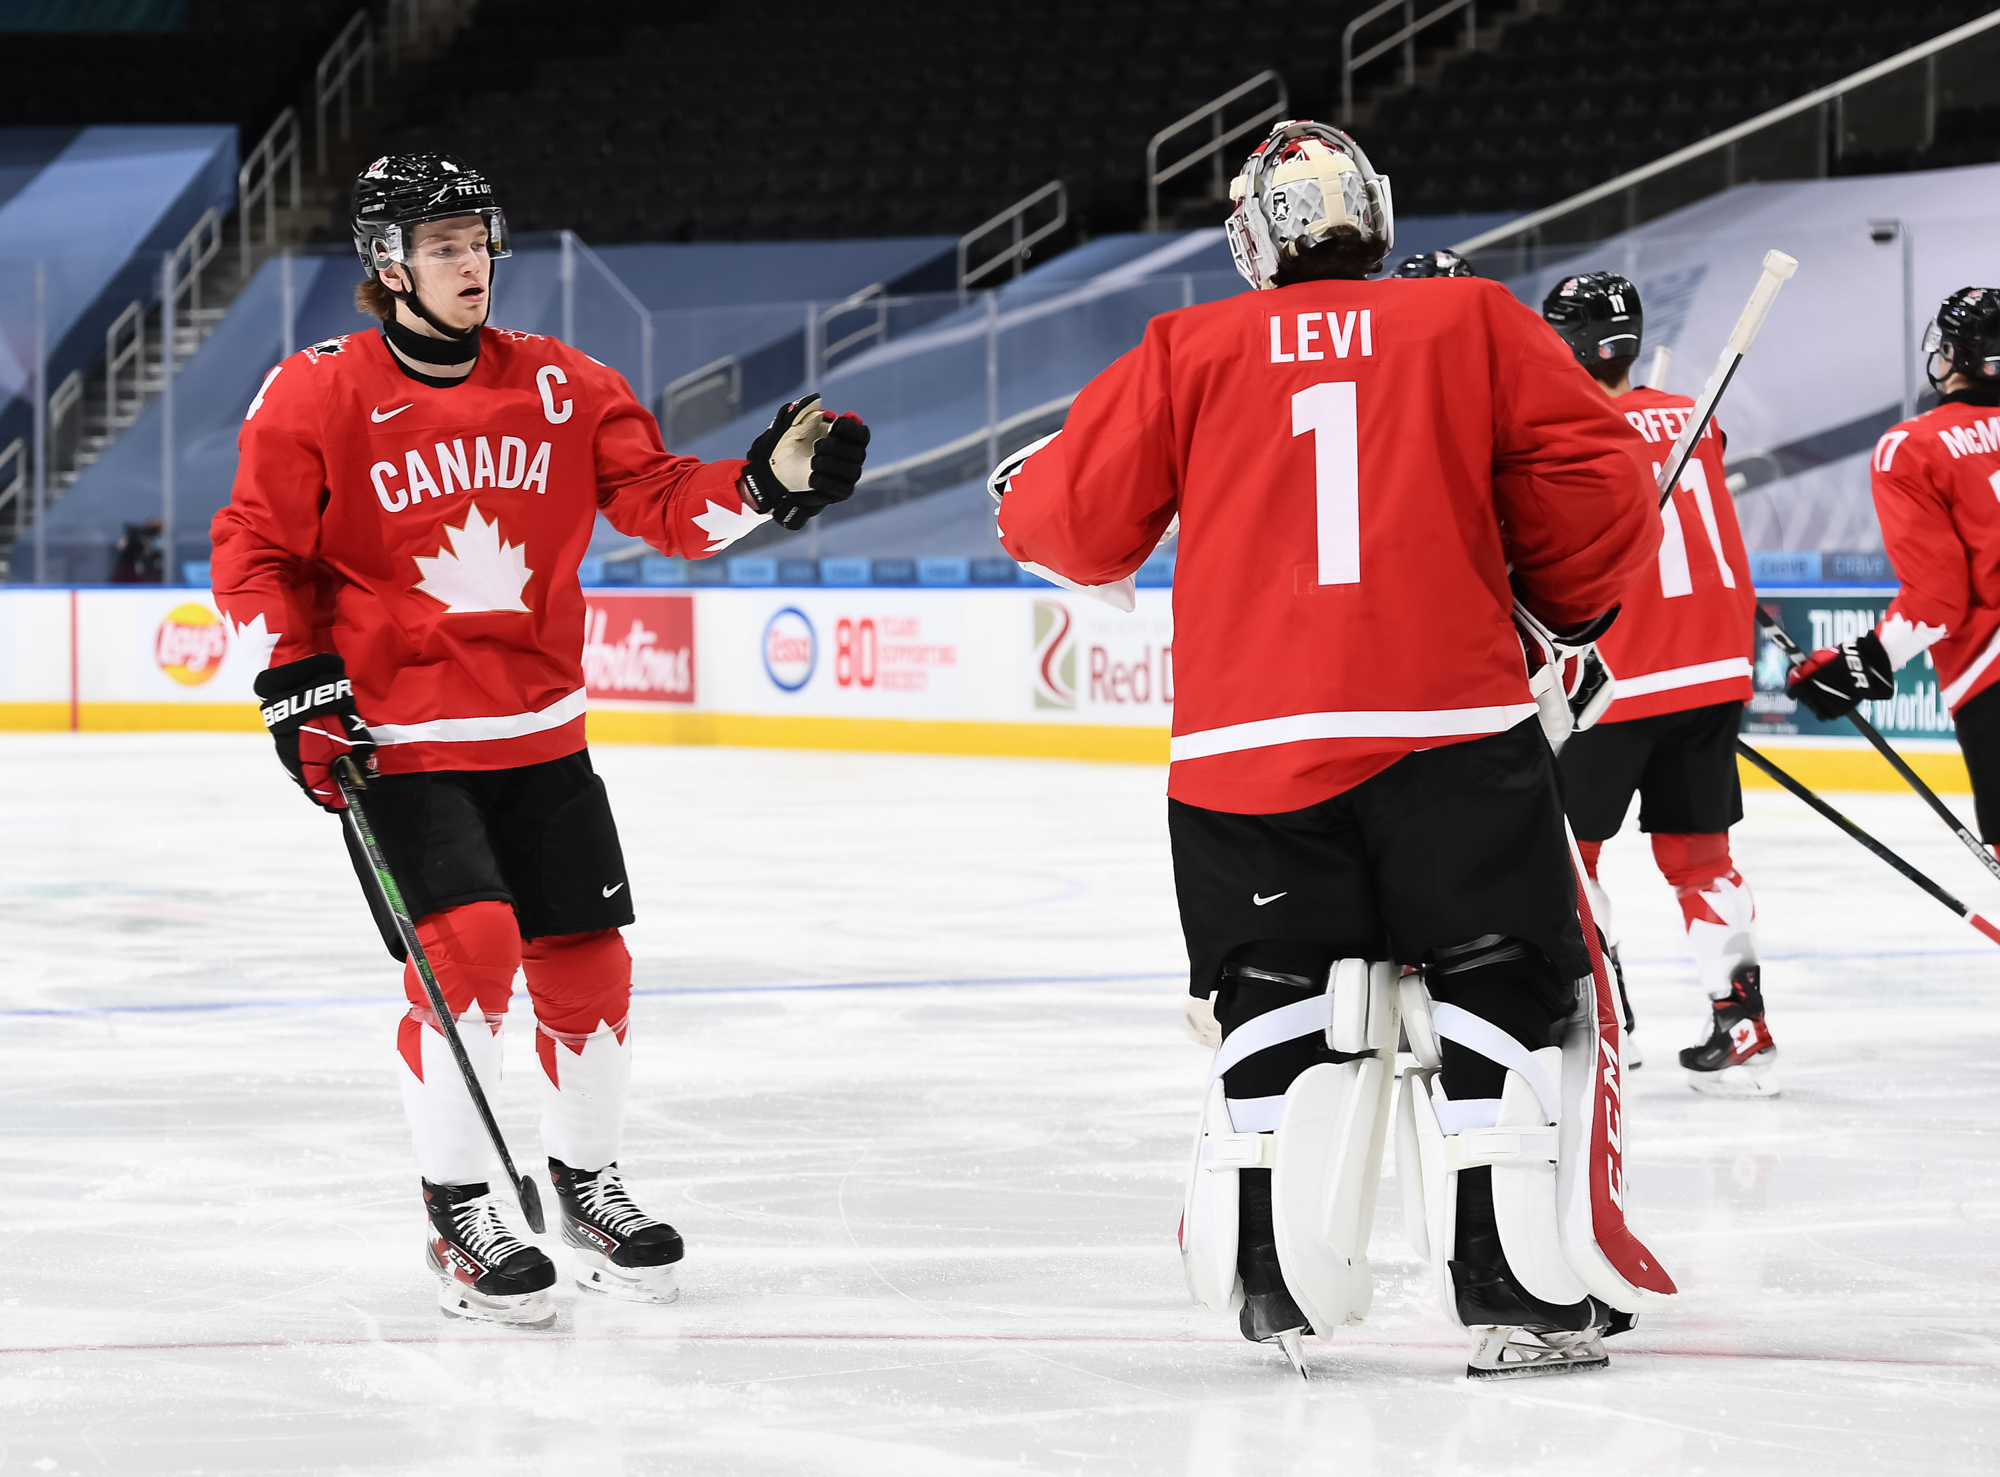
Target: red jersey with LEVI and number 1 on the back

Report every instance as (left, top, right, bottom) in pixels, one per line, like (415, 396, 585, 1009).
(1000, 278, 1660, 815)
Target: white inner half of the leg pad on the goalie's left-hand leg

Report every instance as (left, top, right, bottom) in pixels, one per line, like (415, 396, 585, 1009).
(1270, 959, 1402, 1339)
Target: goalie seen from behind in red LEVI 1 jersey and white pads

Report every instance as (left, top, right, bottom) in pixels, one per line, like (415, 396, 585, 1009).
(992, 122, 1672, 1377)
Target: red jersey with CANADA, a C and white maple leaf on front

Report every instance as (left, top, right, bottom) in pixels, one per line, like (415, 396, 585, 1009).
(210, 328, 764, 773)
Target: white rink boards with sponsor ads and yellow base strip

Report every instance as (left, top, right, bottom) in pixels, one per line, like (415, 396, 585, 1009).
(0, 586, 1968, 791)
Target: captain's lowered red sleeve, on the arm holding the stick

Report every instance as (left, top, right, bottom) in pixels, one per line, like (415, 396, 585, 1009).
(210, 350, 334, 666)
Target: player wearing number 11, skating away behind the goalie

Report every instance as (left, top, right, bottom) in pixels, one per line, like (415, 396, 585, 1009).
(1542, 272, 1778, 1097)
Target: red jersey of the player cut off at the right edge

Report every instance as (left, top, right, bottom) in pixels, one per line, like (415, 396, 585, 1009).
(1870, 404, 2000, 712)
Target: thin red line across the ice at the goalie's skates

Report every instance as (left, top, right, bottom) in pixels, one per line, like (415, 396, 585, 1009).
(0, 1333, 2000, 1371)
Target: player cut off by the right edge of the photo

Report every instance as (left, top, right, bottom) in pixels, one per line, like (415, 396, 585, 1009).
(1786, 286, 2000, 851)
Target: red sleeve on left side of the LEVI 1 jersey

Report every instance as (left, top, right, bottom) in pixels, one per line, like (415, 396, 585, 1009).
(1000, 318, 1180, 584)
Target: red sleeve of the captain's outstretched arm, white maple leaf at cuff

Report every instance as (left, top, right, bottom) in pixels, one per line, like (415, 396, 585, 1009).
(596, 370, 770, 558)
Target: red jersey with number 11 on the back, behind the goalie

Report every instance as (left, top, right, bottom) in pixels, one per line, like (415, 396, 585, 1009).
(1598, 390, 1756, 722)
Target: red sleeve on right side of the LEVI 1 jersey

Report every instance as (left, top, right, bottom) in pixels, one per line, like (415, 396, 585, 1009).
(1488, 284, 1660, 624)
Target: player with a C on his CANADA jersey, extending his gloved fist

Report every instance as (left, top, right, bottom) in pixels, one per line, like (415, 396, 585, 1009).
(212, 154, 868, 1325)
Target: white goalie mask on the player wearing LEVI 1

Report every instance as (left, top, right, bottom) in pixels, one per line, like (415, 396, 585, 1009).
(1226, 120, 1396, 288)
